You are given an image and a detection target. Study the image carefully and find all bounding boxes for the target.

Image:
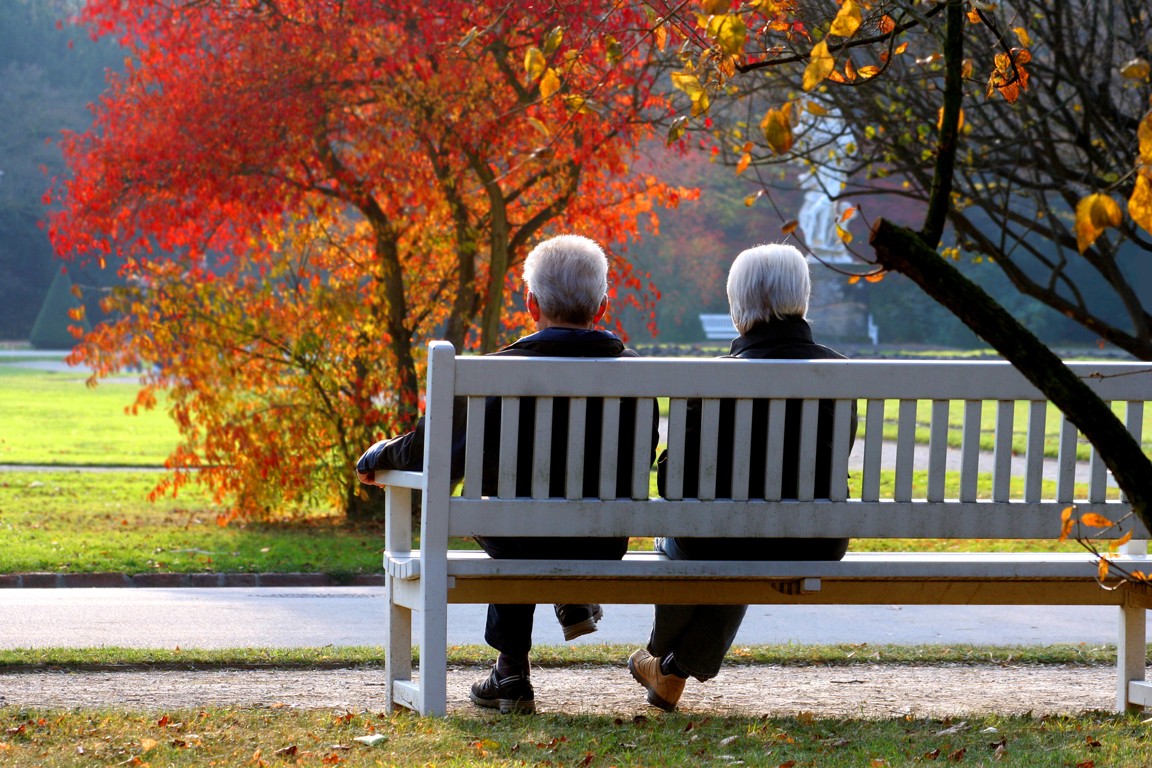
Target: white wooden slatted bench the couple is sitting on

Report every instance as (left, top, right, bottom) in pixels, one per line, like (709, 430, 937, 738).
(376, 342, 1152, 715)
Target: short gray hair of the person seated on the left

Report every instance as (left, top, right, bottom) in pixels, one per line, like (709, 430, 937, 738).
(524, 235, 608, 325)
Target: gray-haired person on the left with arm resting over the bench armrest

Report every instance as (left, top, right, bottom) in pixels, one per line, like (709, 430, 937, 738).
(356, 235, 658, 713)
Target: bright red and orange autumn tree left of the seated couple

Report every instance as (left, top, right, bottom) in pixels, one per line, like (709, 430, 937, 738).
(48, 0, 681, 515)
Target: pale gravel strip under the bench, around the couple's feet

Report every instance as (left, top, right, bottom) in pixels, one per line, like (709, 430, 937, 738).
(0, 664, 1116, 717)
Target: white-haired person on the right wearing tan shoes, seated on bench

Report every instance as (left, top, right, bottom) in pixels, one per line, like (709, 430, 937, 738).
(628, 245, 856, 712)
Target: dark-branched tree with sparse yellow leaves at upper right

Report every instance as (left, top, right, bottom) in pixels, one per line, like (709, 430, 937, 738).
(659, 0, 1152, 524)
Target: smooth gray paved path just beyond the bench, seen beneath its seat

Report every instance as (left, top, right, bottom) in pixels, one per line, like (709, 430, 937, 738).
(0, 587, 1138, 648)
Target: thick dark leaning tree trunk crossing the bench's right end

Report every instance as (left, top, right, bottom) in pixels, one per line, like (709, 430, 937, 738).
(870, 219, 1152, 529)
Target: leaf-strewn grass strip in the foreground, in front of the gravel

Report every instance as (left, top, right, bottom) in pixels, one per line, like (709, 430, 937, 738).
(0, 707, 1150, 768)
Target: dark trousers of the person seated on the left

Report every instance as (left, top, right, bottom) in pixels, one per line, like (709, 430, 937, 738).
(476, 537, 628, 659)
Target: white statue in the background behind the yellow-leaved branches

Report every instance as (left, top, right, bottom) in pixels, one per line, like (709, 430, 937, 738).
(797, 109, 856, 264)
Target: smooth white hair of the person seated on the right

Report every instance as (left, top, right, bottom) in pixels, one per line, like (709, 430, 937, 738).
(728, 243, 812, 334)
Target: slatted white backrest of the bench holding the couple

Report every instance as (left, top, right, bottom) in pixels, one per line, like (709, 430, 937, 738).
(422, 342, 1152, 546)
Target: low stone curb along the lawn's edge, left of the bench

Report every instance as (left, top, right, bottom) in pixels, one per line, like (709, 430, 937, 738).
(0, 573, 384, 590)
